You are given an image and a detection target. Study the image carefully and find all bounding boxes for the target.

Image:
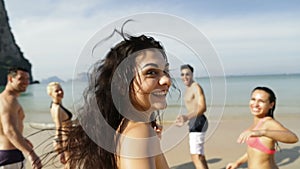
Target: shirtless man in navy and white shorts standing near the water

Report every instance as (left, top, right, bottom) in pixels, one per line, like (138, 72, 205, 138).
(176, 64, 208, 169)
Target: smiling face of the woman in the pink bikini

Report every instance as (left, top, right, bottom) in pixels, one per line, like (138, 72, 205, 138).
(249, 90, 274, 117)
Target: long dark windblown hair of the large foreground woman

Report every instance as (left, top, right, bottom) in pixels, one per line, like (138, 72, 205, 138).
(55, 22, 167, 169)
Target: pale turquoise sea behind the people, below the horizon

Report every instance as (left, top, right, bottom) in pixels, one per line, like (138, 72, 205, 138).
(0, 74, 300, 123)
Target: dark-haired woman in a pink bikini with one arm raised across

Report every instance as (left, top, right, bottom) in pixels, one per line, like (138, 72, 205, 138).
(226, 87, 298, 169)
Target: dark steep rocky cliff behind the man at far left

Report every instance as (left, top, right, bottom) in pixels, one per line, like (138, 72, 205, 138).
(0, 0, 33, 85)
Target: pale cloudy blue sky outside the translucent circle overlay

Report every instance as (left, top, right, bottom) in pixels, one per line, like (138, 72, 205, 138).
(4, 0, 300, 80)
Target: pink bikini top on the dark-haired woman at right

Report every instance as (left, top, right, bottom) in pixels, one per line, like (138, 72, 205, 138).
(247, 118, 276, 154)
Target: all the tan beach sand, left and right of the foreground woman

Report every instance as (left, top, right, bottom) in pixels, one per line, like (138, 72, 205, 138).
(24, 109, 300, 169)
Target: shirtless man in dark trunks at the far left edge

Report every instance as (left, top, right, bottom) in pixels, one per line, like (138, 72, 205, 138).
(0, 68, 42, 169)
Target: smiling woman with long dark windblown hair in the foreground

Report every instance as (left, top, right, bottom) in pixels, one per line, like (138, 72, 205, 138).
(58, 21, 171, 169)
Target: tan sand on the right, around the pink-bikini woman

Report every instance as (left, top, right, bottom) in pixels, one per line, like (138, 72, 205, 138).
(166, 113, 300, 169)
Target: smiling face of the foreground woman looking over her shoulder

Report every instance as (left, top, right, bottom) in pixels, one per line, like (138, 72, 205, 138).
(131, 49, 171, 111)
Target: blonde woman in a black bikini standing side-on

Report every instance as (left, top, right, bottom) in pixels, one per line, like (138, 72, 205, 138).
(47, 82, 72, 168)
